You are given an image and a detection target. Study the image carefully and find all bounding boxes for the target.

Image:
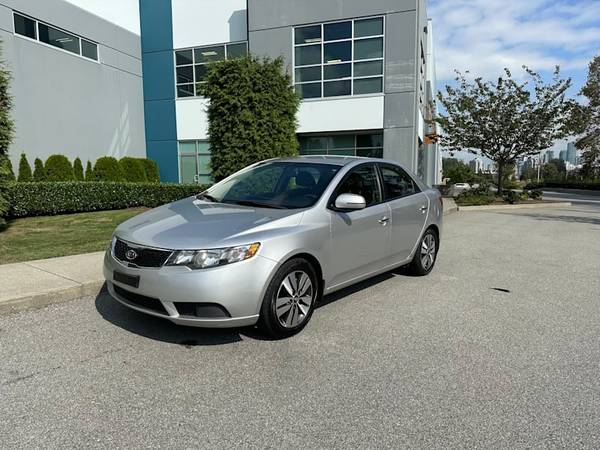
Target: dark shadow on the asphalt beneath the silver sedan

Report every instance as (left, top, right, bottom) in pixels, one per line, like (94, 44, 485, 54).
(95, 269, 407, 348)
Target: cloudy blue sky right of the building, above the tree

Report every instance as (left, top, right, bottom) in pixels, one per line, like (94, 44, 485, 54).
(429, 0, 600, 82)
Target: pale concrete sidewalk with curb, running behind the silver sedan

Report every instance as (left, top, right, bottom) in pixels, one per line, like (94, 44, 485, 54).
(0, 204, 458, 314)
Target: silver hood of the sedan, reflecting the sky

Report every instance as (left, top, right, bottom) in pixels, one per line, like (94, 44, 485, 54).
(116, 197, 301, 249)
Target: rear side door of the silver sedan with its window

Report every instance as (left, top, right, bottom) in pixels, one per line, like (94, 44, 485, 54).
(379, 163, 429, 262)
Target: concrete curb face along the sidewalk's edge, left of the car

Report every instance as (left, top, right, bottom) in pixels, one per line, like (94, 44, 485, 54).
(0, 280, 104, 315)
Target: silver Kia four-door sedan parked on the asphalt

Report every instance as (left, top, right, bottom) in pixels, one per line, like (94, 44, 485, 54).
(104, 156, 442, 337)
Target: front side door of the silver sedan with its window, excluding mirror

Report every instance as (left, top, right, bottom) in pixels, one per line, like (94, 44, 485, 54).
(329, 163, 391, 286)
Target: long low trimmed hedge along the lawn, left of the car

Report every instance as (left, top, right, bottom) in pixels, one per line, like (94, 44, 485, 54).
(7, 181, 206, 217)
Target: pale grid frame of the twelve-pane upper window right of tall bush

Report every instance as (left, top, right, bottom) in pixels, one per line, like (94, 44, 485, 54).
(291, 15, 386, 101)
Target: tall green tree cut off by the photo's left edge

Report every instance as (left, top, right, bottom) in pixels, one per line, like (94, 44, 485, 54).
(0, 43, 15, 229)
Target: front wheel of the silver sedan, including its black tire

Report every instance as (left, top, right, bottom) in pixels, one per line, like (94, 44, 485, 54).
(258, 258, 319, 339)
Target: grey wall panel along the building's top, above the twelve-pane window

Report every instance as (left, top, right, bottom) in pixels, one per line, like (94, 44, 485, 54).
(248, 0, 416, 31)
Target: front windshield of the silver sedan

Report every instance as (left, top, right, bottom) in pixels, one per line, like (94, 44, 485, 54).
(199, 161, 340, 209)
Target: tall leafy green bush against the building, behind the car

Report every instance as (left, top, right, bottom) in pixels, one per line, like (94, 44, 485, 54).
(199, 56, 300, 181)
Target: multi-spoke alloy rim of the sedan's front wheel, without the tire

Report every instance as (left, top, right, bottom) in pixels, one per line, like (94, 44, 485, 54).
(275, 270, 314, 328)
